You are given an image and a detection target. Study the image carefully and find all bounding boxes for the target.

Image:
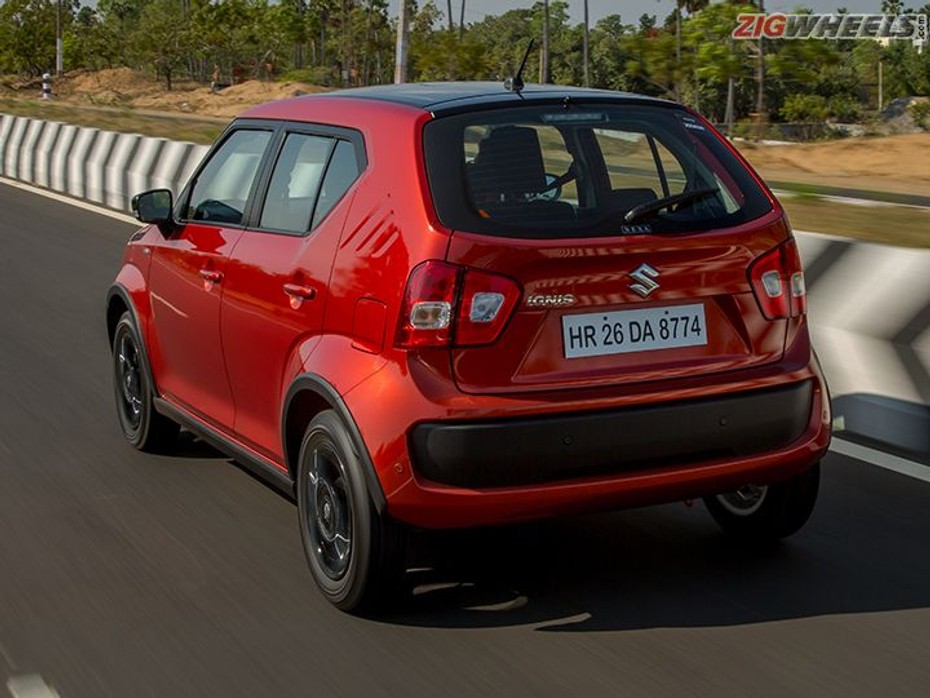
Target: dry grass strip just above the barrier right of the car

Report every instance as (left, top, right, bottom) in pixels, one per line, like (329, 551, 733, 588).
(781, 196, 930, 248)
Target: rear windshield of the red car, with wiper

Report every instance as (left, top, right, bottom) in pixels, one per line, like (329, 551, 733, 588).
(424, 103, 772, 238)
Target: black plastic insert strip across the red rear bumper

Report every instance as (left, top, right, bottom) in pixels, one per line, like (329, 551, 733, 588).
(410, 381, 813, 488)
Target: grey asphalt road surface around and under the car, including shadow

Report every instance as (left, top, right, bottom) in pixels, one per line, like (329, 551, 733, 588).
(0, 185, 930, 698)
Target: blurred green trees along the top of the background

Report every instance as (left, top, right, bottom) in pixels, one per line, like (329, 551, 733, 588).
(0, 0, 930, 123)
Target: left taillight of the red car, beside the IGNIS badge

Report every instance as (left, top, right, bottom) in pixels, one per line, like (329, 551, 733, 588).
(396, 261, 521, 349)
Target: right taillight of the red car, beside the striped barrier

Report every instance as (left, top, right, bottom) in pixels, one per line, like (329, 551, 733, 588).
(749, 240, 807, 320)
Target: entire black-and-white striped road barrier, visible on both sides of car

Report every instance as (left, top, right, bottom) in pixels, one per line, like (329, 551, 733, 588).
(0, 115, 930, 454)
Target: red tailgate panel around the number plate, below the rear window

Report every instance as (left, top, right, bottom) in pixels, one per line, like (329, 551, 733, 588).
(447, 212, 788, 393)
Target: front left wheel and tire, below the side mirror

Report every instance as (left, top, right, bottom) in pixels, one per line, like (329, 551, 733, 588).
(112, 312, 180, 453)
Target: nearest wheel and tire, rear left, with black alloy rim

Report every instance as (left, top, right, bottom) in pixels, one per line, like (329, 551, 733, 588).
(297, 410, 406, 613)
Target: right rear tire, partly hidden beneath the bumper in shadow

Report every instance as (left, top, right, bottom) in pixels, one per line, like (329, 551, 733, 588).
(704, 463, 820, 542)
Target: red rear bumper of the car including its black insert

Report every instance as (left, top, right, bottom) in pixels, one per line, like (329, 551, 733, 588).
(346, 333, 831, 528)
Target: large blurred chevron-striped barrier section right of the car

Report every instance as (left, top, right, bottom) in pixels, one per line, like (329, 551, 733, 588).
(797, 231, 930, 456)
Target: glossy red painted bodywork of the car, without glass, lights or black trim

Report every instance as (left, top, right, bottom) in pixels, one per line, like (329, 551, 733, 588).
(116, 83, 830, 528)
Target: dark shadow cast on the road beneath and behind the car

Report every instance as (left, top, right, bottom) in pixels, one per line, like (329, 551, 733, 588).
(380, 456, 930, 632)
